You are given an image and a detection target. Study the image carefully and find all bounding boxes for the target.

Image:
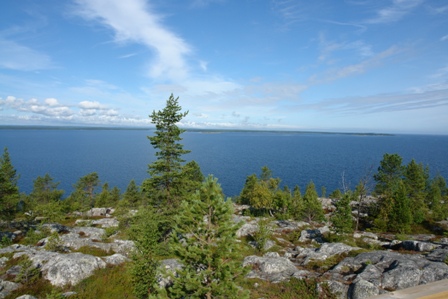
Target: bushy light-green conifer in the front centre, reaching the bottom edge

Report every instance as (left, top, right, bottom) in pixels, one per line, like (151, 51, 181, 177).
(161, 176, 248, 298)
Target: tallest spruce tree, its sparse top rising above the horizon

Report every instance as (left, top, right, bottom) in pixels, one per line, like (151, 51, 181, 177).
(142, 94, 190, 210)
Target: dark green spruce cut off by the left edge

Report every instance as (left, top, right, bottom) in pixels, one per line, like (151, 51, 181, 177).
(0, 148, 20, 220)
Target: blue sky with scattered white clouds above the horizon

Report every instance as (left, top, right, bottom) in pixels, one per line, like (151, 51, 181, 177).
(0, 0, 448, 134)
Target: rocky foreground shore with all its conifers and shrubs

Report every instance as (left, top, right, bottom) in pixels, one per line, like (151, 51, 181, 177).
(0, 95, 448, 299)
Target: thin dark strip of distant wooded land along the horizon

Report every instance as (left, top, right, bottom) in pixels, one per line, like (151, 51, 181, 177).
(0, 125, 397, 136)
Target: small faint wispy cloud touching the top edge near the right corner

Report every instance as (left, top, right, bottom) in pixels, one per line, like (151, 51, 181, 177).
(366, 0, 423, 24)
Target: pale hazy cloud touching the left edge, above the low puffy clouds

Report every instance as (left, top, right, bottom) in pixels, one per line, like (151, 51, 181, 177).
(0, 38, 52, 71)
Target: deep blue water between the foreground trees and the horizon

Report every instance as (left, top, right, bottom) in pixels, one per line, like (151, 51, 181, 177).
(0, 129, 448, 196)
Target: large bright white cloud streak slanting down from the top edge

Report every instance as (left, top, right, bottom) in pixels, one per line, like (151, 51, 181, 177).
(75, 0, 191, 80)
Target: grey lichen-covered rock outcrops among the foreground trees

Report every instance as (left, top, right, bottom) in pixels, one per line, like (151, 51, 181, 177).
(0, 205, 448, 299)
